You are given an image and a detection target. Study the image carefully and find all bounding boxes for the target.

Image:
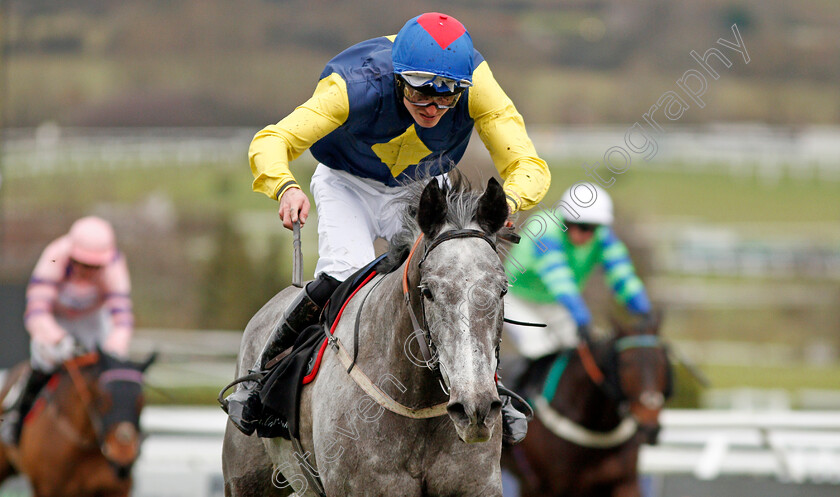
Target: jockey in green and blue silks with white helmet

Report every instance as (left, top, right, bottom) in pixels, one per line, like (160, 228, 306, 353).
(505, 183, 651, 359)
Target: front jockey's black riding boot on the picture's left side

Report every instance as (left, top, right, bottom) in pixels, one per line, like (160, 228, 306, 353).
(222, 274, 340, 435)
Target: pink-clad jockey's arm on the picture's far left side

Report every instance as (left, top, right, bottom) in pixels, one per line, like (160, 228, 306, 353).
(23, 237, 69, 346)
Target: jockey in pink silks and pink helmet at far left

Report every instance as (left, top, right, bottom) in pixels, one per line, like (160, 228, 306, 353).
(2, 216, 134, 445)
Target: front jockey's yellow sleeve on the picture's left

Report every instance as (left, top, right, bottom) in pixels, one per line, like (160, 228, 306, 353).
(253, 73, 350, 199)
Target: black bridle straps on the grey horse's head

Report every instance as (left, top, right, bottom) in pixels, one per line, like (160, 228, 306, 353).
(402, 229, 496, 384)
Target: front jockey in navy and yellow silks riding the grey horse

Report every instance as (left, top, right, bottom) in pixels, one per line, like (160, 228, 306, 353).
(227, 12, 551, 441)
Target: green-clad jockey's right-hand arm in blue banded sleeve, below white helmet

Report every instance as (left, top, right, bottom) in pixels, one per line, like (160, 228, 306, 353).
(599, 228, 651, 315)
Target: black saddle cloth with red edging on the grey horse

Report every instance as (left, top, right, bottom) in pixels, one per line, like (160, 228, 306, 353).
(256, 255, 399, 440)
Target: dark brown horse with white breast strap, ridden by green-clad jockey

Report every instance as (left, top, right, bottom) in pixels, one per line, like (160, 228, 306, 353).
(502, 320, 673, 497)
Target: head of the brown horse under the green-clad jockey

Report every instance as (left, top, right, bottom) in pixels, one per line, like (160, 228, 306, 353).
(607, 316, 674, 444)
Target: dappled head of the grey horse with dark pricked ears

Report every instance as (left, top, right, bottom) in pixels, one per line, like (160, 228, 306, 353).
(408, 175, 508, 443)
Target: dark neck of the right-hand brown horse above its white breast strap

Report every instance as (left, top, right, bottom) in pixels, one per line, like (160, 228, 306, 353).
(552, 351, 621, 431)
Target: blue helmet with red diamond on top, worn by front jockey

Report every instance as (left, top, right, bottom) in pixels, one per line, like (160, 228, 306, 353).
(391, 12, 475, 94)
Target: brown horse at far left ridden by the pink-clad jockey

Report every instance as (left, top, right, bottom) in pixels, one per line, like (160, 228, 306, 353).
(0, 352, 154, 497)
